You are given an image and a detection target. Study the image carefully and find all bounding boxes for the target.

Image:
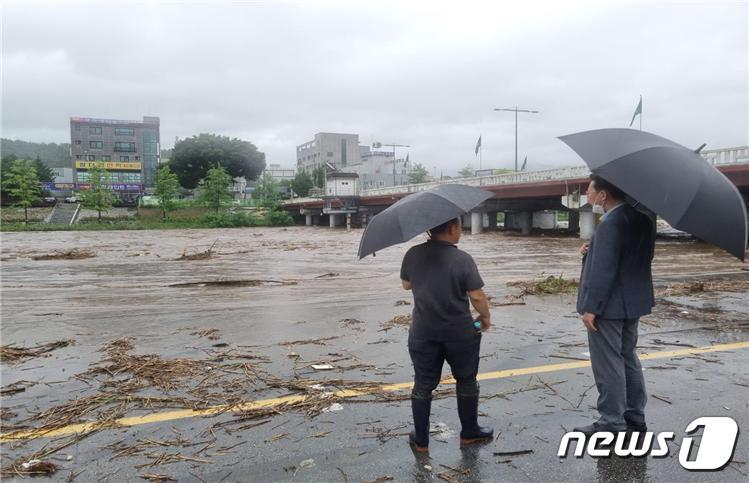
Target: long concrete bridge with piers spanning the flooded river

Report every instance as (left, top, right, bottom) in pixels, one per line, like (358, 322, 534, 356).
(283, 146, 749, 238)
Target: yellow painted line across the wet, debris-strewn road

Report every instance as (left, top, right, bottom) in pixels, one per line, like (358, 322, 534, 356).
(0, 341, 749, 442)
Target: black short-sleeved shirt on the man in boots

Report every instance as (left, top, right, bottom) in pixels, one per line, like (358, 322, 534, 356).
(401, 240, 484, 341)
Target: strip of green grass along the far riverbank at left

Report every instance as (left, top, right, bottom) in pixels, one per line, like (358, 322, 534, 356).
(0, 211, 294, 232)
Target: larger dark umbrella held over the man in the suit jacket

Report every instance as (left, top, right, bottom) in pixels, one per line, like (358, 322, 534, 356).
(559, 129, 747, 261)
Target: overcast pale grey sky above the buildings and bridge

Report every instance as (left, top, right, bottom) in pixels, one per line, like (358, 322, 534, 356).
(2, 0, 749, 174)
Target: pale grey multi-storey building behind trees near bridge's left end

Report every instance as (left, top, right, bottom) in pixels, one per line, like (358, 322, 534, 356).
(296, 132, 359, 171)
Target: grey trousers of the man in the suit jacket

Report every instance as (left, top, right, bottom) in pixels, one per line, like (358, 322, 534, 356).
(588, 319, 647, 430)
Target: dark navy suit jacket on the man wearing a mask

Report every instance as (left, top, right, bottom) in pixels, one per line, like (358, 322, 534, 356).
(577, 204, 656, 319)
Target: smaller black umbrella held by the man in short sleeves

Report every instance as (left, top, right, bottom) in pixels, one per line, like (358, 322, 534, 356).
(359, 184, 494, 259)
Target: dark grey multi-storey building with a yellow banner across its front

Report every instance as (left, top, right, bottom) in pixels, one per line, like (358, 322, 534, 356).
(70, 116, 160, 199)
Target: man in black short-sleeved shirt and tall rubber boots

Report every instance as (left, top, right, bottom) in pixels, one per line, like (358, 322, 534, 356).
(401, 218, 494, 452)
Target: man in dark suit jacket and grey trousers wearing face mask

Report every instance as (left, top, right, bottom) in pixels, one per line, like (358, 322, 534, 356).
(575, 175, 655, 435)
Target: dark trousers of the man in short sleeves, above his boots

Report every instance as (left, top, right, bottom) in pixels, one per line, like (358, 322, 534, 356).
(408, 334, 481, 399)
